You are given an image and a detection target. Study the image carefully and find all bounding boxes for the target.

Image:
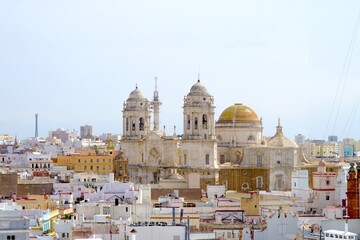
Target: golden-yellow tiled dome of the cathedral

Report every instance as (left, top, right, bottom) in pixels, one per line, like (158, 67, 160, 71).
(218, 103, 260, 123)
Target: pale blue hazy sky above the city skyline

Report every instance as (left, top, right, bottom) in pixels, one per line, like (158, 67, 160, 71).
(0, 0, 360, 139)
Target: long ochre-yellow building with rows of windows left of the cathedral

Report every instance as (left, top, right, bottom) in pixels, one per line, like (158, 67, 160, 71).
(55, 153, 114, 174)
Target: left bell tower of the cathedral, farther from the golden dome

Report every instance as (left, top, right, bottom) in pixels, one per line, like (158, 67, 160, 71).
(123, 86, 151, 140)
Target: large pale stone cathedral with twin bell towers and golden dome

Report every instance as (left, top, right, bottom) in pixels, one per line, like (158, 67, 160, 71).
(121, 80, 301, 192)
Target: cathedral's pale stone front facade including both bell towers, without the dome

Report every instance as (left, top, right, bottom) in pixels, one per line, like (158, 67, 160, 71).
(121, 81, 218, 186)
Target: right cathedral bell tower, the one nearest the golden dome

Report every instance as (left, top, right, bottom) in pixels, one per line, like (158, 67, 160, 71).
(183, 79, 215, 140)
